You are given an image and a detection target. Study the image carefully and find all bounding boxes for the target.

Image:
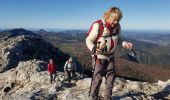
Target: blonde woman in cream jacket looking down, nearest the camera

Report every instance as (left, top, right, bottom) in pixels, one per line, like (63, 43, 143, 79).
(86, 7, 133, 100)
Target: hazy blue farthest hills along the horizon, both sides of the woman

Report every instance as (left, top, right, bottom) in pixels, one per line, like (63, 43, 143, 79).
(36, 29, 170, 46)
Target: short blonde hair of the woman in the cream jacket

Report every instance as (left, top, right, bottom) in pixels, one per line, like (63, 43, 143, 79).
(103, 7, 123, 21)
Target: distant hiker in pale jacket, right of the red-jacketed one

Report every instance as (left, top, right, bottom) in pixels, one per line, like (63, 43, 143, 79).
(64, 57, 76, 82)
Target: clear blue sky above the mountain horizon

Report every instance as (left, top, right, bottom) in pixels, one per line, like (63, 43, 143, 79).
(0, 0, 170, 30)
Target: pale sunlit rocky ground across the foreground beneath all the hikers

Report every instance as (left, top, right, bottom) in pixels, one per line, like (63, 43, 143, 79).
(0, 59, 170, 100)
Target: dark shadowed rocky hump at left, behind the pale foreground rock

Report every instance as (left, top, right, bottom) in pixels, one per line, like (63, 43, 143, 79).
(0, 29, 65, 72)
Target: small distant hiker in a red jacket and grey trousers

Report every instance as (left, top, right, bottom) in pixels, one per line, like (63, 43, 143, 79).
(48, 59, 57, 84)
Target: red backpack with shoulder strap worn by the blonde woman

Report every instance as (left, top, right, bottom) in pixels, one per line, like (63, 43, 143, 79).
(86, 20, 104, 44)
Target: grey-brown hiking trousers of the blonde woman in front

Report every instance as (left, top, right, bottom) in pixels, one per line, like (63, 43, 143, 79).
(90, 58, 115, 100)
